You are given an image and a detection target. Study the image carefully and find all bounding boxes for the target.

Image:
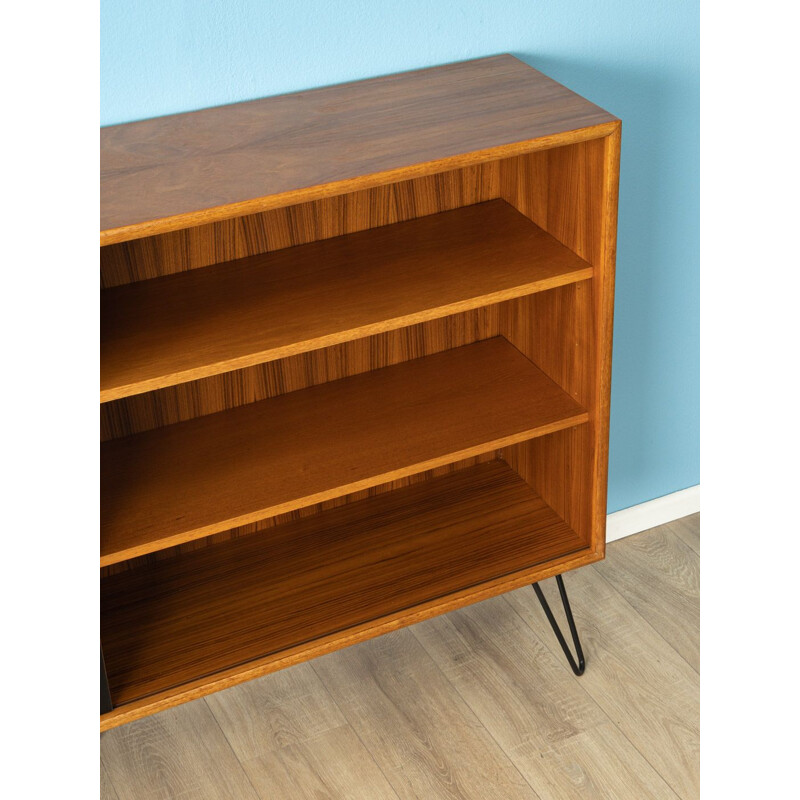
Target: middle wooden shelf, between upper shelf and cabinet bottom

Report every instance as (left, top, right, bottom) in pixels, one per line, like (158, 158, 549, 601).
(101, 337, 588, 566)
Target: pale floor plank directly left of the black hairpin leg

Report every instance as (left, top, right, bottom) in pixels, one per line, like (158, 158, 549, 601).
(412, 589, 676, 800)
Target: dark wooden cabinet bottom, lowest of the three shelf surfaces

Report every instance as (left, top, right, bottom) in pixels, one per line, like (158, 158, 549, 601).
(101, 461, 587, 712)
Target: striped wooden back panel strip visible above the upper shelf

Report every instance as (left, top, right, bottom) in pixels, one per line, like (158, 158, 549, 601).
(100, 161, 500, 288)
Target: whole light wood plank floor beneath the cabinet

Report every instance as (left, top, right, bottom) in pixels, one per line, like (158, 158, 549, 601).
(100, 514, 700, 800)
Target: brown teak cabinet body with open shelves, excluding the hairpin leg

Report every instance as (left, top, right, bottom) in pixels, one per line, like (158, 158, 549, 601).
(100, 55, 620, 729)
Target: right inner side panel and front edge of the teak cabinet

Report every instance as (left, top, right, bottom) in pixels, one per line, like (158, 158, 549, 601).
(500, 131, 619, 554)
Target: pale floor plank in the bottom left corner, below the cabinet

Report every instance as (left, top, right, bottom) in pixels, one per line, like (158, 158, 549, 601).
(100, 701, 259, 800)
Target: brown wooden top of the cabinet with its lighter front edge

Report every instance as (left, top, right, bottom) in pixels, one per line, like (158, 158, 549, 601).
(100, 55, 618, 244)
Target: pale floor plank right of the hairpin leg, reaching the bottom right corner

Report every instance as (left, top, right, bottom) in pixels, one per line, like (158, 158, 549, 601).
(506, 556, 700, 800)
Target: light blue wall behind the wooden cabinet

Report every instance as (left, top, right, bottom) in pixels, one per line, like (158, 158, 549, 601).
(101, 0, 699, 511)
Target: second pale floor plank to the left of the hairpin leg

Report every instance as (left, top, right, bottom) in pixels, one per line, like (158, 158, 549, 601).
(312, 629, 537, 800)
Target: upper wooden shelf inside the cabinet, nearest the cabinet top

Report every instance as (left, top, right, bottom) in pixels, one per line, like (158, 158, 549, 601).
(100, 200, 592, 402)
